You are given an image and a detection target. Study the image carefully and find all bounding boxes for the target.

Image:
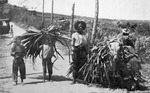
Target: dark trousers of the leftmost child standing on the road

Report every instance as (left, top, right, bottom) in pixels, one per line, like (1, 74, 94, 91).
(12, 58, 26, 82)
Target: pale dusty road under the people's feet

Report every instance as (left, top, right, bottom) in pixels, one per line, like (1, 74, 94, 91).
(0, 24, 150, 93)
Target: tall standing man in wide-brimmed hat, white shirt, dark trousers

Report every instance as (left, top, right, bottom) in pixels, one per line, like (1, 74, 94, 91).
(71, 21, 88, 84)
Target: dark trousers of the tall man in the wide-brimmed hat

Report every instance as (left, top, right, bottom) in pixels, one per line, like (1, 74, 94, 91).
(72, 47, 87, 79)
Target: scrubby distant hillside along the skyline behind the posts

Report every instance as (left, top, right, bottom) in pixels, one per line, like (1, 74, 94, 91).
(3, 4, 150, 35)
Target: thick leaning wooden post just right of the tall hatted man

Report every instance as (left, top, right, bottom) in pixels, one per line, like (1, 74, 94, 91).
(91, 0, 99, 44)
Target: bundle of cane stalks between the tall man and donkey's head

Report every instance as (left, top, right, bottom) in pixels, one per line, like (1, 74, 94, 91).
(79, 44, 111, 85)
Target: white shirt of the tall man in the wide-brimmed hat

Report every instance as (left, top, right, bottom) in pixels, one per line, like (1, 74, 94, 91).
(71, 32, 87, 46)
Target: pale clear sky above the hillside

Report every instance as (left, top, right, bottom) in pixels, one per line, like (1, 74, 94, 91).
(8, 0, 150, 20)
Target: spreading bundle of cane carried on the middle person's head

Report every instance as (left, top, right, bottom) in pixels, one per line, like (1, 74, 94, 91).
(22, 26, 69, 63)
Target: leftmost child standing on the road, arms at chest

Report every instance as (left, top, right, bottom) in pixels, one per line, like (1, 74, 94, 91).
(11, 36, 26, 85)
